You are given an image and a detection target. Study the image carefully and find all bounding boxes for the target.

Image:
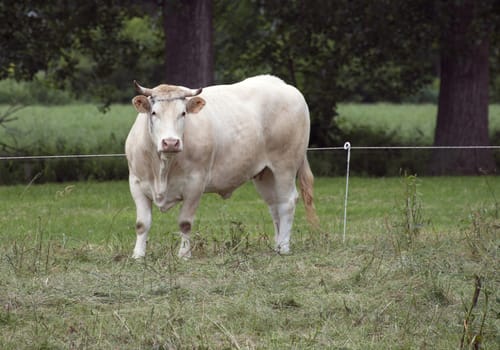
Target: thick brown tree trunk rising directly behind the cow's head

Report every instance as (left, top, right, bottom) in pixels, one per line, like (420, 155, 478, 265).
(163, 0, 214, 88)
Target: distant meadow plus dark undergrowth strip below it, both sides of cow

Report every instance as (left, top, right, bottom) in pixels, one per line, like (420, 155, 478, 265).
(0, 103, 500, 184)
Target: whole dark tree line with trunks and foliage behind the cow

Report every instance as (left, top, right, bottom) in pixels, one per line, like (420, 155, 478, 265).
(0, 0, 500, 174)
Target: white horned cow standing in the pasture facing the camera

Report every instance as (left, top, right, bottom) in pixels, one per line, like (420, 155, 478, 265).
(125, 75, 317, 258)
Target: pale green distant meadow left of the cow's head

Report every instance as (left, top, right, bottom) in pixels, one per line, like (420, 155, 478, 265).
(0, 104, 137, 155)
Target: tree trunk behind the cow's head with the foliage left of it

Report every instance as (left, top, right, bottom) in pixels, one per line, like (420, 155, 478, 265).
(0, 0, 213, 105)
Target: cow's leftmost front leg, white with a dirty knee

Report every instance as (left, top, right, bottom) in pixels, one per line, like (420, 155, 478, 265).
(129, 177, 152, 259)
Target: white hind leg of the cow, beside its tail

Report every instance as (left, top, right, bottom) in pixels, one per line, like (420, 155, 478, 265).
(254, 168, 298, 254)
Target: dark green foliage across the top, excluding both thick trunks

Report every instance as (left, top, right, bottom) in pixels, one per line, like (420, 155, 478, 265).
(0, 0, 500, 150)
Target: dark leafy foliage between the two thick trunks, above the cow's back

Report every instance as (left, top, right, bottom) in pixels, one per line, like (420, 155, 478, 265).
(215, 1, 440, 146)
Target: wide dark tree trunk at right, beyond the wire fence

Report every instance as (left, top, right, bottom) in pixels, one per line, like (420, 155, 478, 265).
(430, 0, 495, 175)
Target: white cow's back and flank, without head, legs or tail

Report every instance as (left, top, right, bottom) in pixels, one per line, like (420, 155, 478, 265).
(185, 76, 309, 193)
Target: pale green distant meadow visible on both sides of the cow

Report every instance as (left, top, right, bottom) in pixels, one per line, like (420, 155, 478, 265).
(0, 103, 500, 153)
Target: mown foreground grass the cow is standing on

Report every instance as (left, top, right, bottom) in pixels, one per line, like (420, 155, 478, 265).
(0, 177, 500, 349)
